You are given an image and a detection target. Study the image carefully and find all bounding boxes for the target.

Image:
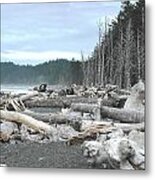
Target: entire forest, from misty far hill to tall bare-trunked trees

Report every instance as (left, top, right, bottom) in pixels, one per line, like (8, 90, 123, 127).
(0, 0, 145, 88)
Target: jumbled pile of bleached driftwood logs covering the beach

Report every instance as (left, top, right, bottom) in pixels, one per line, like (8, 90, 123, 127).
(0, 81, 145, 169)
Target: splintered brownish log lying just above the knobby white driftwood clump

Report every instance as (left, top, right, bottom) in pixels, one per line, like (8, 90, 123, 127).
(67, 120, 145, 145)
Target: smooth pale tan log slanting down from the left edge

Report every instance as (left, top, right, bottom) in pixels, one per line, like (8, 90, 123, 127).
(0, 110, 56, 135)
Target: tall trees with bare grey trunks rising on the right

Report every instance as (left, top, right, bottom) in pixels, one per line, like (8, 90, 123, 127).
(82, 0, 145, 88)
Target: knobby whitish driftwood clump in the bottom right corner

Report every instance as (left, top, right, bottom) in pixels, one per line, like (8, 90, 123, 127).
(82, 133, 145, 170)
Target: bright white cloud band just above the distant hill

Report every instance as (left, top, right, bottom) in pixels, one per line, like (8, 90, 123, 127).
(1, 51, 81, 65)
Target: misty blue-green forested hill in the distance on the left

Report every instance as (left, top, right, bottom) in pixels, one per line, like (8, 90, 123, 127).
(0, 59, 83, 85)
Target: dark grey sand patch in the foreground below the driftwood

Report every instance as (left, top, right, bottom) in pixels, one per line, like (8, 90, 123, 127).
(0, 143, 89, 169)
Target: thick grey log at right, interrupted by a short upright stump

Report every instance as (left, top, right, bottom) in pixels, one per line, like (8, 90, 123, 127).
(71, 103, 144, 123)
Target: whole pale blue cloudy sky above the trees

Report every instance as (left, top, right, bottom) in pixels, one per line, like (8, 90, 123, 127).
(1, 1, 121, 65)
